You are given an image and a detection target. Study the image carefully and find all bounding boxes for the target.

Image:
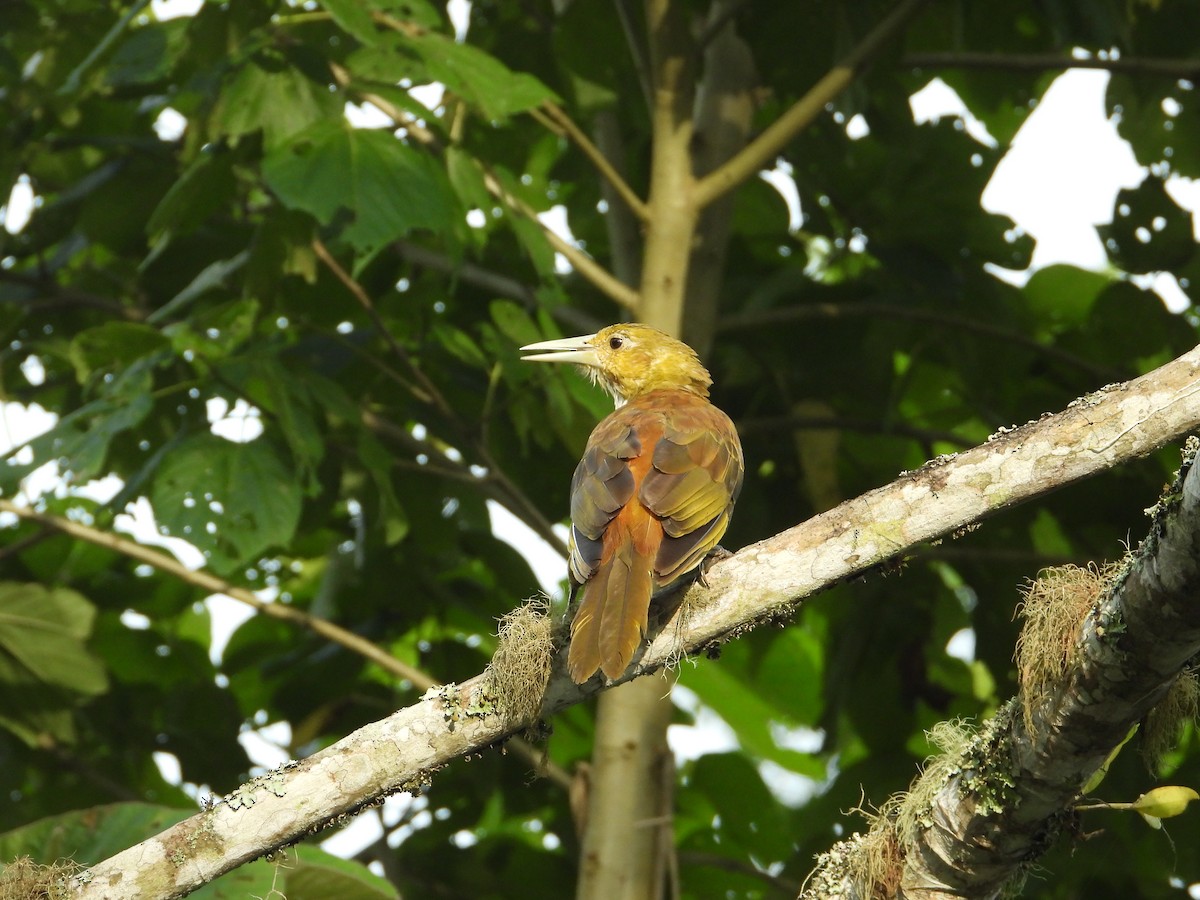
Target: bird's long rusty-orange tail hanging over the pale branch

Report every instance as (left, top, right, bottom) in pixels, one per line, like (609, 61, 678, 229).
(566, 508, 662, 684)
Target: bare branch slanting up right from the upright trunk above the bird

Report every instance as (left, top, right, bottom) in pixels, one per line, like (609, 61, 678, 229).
(695, 0, 929, 208)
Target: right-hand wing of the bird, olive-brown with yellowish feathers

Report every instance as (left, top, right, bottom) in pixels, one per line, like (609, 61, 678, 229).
(640, 402, 743, 584)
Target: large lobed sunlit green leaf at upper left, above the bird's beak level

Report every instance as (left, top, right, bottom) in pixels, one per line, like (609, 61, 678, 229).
(263, 121, 457, 254)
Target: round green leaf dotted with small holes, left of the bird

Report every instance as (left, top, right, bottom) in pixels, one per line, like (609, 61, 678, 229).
(150, 434, 300, 572)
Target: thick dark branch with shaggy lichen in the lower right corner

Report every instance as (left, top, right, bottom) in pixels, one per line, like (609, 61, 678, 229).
(803, 438, 1200, 900)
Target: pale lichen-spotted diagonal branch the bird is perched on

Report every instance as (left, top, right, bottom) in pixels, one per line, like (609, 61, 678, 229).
(73, 348, 1200, 900)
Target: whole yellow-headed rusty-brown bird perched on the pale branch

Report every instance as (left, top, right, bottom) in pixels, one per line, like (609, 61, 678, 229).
(521, 323, 745, 684)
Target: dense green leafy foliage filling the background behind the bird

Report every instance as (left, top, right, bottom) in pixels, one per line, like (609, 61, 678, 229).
(0, 0, 1200, 898)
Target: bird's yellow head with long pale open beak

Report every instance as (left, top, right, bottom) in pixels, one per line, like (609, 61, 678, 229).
(521, 323, 713, 406)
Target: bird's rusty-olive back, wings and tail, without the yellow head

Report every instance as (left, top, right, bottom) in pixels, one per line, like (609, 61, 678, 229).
(568, 389, 743, 683)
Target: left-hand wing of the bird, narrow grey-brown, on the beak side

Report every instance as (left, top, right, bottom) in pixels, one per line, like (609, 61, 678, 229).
(571, 414, 642, 584)
